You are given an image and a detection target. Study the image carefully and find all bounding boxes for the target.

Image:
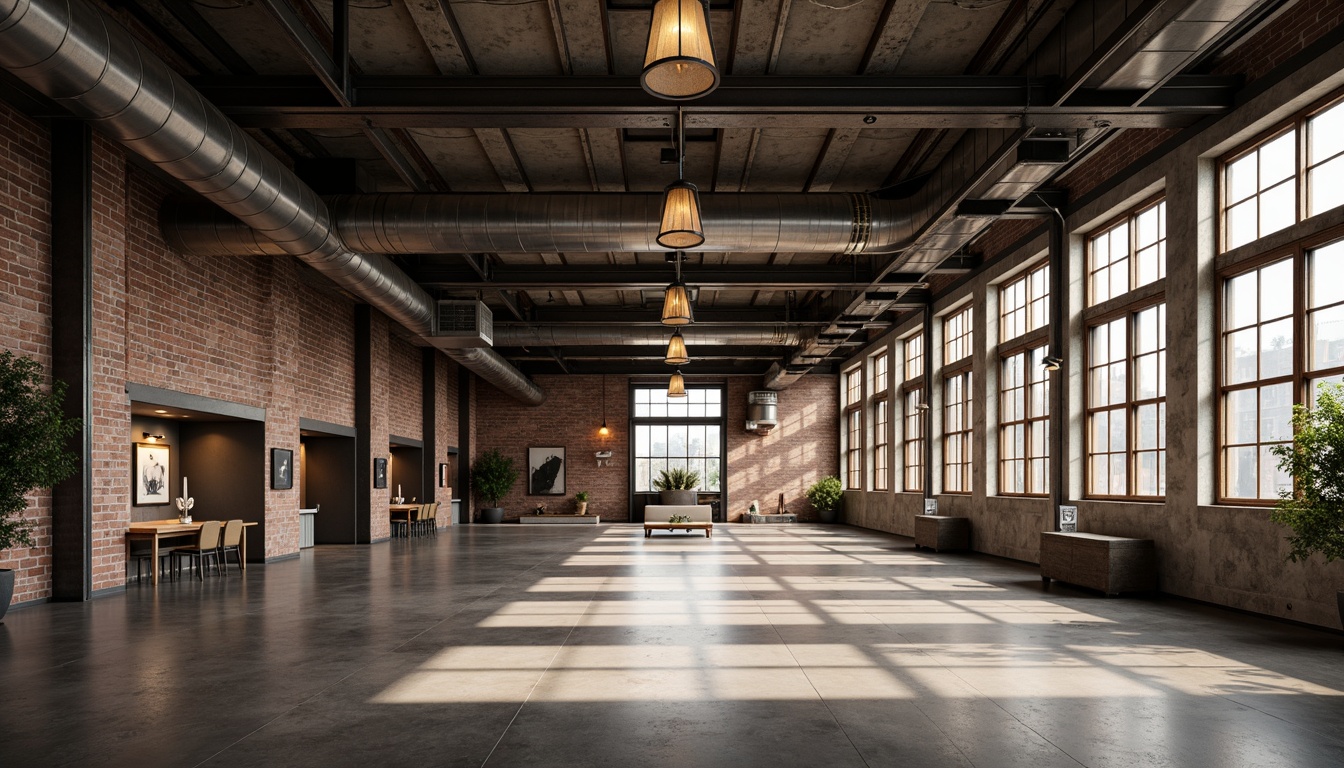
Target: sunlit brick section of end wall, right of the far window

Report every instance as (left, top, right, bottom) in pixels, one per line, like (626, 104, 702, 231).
(726, 374, 840, 521)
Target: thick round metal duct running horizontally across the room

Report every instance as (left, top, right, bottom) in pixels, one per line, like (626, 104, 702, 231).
(160, 194, 915, 256)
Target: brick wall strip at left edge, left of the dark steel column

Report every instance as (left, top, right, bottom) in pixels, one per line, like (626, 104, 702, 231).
(0, 102, 51, 603)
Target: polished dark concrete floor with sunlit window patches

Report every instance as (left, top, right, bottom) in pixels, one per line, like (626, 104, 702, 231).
(0, 525, 1344, 768)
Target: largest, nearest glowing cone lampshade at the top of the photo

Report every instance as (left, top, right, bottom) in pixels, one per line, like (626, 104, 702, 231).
(640, 0, 719, 100)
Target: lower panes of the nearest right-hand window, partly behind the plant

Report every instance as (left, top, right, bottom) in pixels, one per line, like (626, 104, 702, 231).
(1220, 241, 1344, 503)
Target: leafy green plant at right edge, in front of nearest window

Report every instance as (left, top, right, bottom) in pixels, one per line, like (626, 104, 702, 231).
(1270, 383, 1344, 620)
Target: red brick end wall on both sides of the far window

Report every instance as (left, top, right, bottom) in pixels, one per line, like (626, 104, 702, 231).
(476, 375, 839, 521)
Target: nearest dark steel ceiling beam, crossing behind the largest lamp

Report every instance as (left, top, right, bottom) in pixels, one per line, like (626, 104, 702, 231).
(192, 74, 1241, 129)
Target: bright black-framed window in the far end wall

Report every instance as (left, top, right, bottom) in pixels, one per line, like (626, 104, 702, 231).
(630, 385, 724, 492)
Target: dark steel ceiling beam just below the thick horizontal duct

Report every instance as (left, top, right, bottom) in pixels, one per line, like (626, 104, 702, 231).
(406, 262, 921, 291)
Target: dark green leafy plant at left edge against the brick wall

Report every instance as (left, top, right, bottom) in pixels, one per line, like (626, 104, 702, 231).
(0, 351, 79, 619)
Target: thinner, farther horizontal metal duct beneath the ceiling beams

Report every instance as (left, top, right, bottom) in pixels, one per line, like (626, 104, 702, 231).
(495, 325, 809, 348)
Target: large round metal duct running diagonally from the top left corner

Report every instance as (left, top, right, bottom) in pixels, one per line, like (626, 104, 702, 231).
(0, 0, 544, 405)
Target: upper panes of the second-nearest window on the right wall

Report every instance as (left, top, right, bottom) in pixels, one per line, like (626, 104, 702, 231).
(1087, 200, 1167, 305)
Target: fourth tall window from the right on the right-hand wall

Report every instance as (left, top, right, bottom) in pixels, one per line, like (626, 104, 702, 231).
(942, 307, 974, 494)
